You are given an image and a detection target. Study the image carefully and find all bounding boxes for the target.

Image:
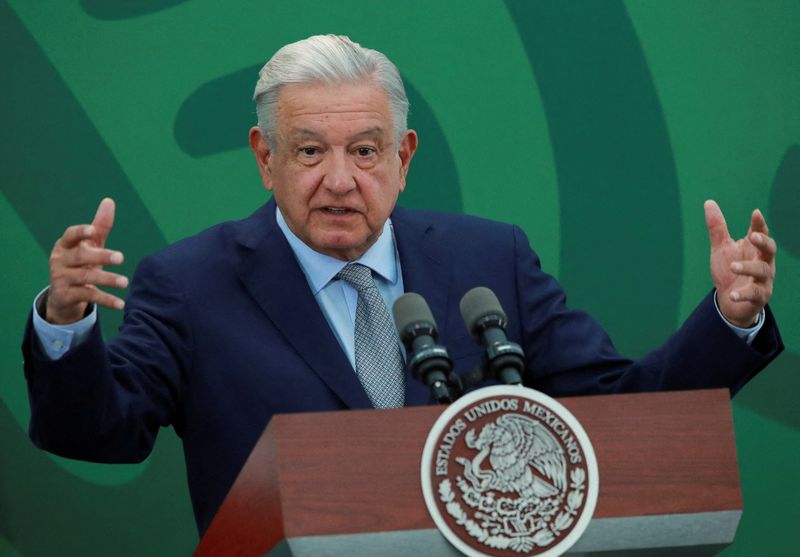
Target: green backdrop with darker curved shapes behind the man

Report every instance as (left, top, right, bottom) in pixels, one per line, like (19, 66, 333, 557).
(0, 0, 800, 557)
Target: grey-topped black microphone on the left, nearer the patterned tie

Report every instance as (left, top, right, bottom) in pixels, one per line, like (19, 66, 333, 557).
(392, 292, 454, 404)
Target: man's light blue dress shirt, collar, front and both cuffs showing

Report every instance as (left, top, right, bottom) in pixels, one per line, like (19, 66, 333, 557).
(33, 207, 764, 360)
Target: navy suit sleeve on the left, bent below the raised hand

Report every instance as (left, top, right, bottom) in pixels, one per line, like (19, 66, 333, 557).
(22, 254, 192, 462)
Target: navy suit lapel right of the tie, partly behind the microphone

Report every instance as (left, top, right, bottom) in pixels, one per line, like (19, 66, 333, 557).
(392, 208, 452, 406)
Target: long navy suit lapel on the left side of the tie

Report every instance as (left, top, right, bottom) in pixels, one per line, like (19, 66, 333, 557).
(230, 200, 372, 408)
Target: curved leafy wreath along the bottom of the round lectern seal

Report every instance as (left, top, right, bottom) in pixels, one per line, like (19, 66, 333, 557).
(438, 468, 586, 553)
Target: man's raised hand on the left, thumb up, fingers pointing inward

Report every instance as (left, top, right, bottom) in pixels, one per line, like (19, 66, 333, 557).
(43, 198, 128, 325)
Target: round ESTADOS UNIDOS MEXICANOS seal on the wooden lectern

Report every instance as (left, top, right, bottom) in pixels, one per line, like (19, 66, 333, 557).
(422, 386, 598, 557)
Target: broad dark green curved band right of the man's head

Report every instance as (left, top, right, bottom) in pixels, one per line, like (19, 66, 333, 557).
(506, 0, 683, 356)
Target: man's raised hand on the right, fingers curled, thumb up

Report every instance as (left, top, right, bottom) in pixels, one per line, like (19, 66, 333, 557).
(705, 200, 777, 328)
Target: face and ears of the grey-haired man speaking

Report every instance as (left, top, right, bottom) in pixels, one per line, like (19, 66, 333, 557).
(250, 82, 417, 260)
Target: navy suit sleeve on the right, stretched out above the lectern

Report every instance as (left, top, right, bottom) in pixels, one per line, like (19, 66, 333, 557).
(514, 227, 783, 396)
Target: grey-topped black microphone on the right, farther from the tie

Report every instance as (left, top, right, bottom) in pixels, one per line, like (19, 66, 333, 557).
(459, 286, 525, 385)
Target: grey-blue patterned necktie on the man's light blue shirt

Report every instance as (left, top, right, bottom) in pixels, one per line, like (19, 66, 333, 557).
(336, 263, 405, 408)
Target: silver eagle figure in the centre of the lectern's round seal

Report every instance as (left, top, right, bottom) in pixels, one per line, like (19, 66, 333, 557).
(457, 414, 567, 499)
